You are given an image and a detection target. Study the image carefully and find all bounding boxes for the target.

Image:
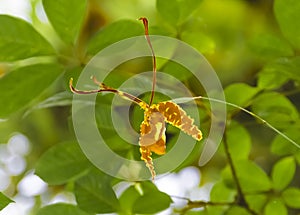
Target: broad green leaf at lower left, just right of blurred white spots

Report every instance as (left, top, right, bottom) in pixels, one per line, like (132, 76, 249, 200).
(35, 142, 91, 185)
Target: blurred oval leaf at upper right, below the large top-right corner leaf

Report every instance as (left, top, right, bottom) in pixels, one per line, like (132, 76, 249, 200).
(250, 34, 294, 59)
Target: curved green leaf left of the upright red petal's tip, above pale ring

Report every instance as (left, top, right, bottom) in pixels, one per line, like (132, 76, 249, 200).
(87, 20, 143, 55)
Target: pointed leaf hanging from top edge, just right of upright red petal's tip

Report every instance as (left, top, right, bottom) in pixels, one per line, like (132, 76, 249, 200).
(156, 0, 180, 26)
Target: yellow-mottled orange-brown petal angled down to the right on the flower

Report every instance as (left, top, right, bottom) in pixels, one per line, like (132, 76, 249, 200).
(151, 101, 202, 141)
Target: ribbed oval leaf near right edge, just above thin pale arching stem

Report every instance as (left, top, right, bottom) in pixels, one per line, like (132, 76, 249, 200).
(252, 92, 299, 128)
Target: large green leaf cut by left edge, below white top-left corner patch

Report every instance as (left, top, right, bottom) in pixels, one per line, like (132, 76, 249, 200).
(0, 15, 55, 61)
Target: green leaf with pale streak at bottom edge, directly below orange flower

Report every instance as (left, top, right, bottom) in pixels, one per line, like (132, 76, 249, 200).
(120, 181, 172, 214)
